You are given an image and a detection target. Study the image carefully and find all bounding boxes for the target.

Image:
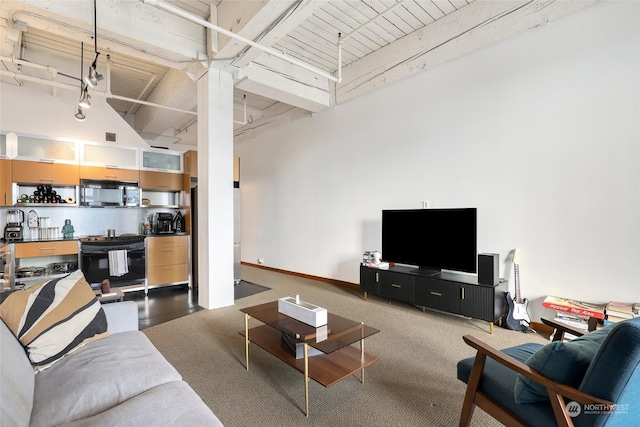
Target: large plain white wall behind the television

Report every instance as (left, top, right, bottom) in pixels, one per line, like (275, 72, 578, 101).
(236, 2, 640, 316)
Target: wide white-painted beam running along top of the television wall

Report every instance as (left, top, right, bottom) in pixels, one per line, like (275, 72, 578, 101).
(336, 0, 598, 104)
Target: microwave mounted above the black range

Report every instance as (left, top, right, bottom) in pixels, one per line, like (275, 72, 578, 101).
(80, 179, 140, 208)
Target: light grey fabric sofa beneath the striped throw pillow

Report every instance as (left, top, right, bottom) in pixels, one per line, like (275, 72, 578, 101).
(0, 270, 222, 426)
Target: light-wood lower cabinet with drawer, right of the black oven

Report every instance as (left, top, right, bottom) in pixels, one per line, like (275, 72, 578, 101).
(147, 235, 189, 288)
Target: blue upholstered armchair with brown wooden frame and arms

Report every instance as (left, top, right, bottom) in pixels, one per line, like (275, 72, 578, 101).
(457, 318, 640, 427)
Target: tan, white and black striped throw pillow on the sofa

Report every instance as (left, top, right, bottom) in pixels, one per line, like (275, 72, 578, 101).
(0, 270, 109, 372)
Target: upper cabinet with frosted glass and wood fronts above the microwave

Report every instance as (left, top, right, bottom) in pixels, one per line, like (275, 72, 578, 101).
(80, 143, 140, 182)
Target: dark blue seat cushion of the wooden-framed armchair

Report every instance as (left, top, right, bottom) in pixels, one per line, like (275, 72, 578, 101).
(457, 343, 556, 427)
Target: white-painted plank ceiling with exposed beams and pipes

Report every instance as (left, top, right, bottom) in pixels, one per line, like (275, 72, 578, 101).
(0, 0, 595, 147)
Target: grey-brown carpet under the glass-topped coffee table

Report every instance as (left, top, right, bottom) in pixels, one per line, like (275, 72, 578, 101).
(144, 266, 545, 427)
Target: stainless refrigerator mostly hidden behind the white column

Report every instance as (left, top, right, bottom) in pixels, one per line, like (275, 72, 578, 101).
(191, 185, 240, 288)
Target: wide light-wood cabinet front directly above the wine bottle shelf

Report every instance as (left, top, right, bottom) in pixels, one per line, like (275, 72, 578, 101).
(12, 159, 80, 185)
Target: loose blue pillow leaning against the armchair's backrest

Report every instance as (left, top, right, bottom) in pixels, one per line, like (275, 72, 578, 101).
(513, 325, 613, 403)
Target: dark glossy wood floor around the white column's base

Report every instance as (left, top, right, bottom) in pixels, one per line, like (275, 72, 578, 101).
(124, 280, 269, 330)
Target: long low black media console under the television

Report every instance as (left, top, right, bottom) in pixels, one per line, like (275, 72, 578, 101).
(360, 265, 507, 333)
